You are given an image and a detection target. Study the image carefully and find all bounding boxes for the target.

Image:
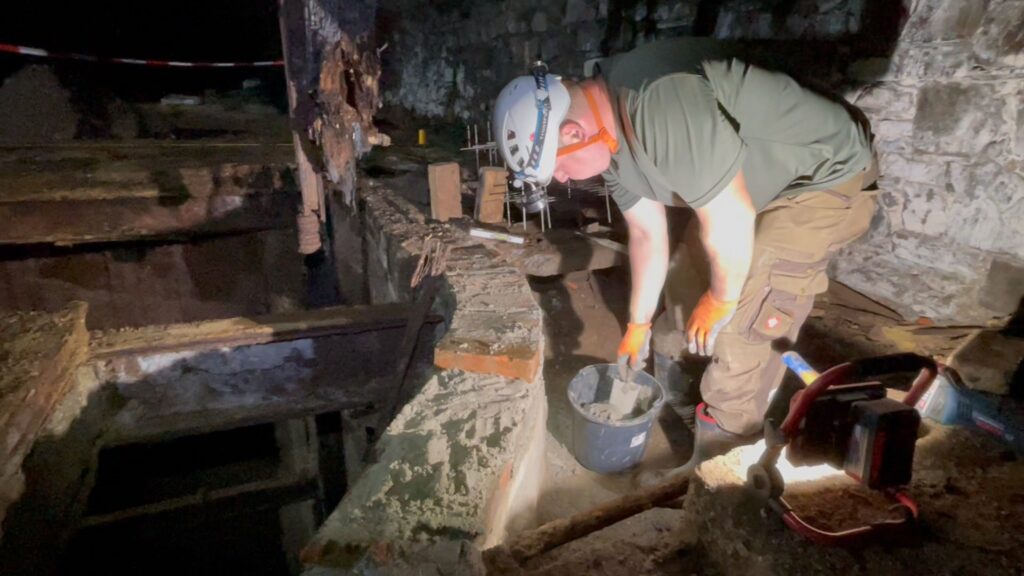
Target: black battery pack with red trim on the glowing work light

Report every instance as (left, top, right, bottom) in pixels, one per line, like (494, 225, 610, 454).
(843, 398, 921, 490)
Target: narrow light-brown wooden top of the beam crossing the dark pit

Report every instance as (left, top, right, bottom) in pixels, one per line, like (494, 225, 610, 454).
(89, 303, 443, 359)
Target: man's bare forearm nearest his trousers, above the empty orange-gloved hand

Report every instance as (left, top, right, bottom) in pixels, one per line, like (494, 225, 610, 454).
(696, 171, 757, 302)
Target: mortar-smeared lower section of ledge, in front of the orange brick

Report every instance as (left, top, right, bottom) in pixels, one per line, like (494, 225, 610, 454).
(302, 371, 546, 570)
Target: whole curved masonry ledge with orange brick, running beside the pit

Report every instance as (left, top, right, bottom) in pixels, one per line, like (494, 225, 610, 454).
(302, 180, 547, 575)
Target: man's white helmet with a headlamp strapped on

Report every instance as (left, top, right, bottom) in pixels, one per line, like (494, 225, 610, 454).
(494, 63, 570, 186)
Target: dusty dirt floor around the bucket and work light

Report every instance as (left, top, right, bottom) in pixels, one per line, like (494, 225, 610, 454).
(529, 269, 1024, 575)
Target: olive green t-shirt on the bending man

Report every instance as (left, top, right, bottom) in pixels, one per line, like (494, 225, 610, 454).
(598, 39, 871, 211)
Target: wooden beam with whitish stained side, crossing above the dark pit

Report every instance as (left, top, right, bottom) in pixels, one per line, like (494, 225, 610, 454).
(91, 304, 442, 445)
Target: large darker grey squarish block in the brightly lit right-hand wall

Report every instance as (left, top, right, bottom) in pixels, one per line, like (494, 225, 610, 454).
(913, 82, 1009, 156)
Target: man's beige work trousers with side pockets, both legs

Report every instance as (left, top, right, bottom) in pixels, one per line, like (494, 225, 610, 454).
(654, 163, 878, 435)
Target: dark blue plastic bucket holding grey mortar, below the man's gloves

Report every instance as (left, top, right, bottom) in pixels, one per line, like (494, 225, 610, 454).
(567, 364, 665, 474)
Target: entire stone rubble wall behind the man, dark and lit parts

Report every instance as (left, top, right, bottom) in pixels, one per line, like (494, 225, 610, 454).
(380, 0, 1024, 324)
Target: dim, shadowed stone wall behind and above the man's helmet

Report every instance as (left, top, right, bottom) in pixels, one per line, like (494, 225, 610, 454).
(379, 0, 697, 124)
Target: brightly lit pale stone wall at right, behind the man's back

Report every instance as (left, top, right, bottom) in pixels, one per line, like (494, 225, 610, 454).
(835, 0, 1024, 324)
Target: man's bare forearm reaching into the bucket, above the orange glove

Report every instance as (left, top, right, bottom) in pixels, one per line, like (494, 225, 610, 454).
(623, 198, 669, 324)
